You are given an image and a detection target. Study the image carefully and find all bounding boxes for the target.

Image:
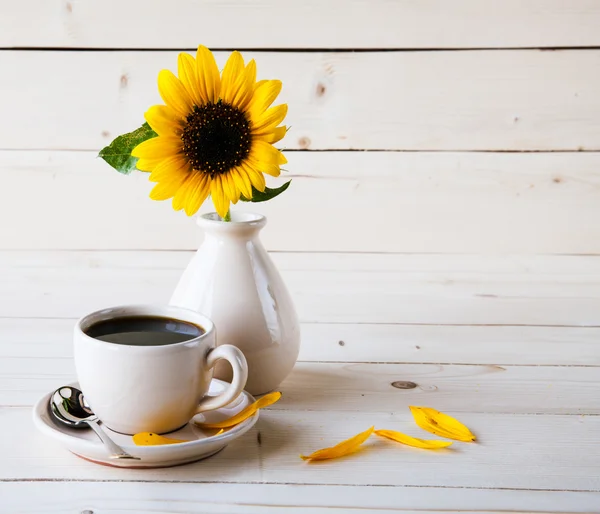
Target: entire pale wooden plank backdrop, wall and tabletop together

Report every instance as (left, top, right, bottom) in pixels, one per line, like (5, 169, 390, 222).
(0, 0, 600, 508)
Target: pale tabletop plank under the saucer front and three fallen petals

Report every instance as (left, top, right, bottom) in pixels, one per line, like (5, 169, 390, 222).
(0, 408, 600, 494)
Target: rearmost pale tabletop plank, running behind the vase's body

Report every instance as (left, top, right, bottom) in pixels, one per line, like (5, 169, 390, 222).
(0, 252, 600, 326)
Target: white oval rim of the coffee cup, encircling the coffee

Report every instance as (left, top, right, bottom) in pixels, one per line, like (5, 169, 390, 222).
(75, 304, 215, 351)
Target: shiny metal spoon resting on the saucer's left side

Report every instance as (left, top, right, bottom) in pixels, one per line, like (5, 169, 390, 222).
(50, 386, 140, 460)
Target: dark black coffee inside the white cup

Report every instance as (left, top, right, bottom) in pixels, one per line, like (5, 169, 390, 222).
(85, 316, 204, 346)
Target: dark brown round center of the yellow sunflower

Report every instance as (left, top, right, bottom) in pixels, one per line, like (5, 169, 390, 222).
(181, 100, 251, 177)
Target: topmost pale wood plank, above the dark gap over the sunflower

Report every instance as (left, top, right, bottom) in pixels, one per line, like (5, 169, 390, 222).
(0, 0, 600, 48)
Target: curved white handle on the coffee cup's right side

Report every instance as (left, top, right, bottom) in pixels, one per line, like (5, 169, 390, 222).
(196, 344, 248, 414)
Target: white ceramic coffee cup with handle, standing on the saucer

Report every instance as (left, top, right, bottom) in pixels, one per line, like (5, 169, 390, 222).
(74, 305, 248, 434)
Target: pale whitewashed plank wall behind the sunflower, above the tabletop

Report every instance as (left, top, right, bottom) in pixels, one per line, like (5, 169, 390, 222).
(0, 4, 600, 254)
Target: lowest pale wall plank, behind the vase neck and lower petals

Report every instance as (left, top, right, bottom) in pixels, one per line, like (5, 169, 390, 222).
(0, 149, 600, 253)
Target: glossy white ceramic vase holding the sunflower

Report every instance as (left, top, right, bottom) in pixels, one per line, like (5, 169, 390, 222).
(170, 213, 300, 394)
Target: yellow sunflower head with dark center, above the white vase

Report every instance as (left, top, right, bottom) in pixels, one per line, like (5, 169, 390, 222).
(131, 46, 287, 217)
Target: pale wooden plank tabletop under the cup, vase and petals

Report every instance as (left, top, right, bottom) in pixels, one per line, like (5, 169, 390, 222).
(0, 251, 600, 514)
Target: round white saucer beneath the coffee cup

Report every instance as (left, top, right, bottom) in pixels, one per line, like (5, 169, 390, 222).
(33, 379, 258, 468)
